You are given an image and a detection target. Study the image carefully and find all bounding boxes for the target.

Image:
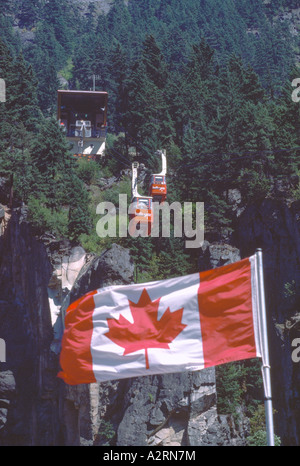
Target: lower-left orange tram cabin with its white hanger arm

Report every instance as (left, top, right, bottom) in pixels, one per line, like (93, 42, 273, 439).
(129, 162, 153, 235)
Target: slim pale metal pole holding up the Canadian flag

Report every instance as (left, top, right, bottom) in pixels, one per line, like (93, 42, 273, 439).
(255, 248, 275, 446)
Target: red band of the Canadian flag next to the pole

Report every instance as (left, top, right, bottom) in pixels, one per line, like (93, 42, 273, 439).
(198, 259, 256, 367)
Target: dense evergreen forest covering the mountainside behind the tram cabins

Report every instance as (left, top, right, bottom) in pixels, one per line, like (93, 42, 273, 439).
(0, 0, 300, 446)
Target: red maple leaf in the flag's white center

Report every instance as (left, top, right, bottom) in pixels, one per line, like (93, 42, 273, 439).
(105, 288, 186, 369)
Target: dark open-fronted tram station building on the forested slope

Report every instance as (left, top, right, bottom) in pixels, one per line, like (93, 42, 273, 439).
(57, 90, 108, 158)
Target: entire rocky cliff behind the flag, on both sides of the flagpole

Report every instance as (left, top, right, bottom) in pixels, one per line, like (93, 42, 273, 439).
(0, 199, 300, 446)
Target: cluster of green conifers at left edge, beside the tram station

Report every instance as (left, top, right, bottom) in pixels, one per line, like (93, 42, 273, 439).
(0, 37, 90, 239)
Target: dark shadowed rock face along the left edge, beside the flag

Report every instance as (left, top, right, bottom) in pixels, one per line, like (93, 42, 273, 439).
(0, 209, 59, 445)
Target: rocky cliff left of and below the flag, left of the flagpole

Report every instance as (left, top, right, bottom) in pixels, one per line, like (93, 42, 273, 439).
(0, 208, 244, 446)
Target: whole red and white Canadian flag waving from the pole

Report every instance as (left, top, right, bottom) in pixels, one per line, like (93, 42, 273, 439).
(58, 256, 261, 385)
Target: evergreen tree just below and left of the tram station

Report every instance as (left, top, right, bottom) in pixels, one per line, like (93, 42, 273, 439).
(31, 119, 90, 239)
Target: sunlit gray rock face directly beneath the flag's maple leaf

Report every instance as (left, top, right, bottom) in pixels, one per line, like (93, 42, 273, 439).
(111, 368, 243, 446)
